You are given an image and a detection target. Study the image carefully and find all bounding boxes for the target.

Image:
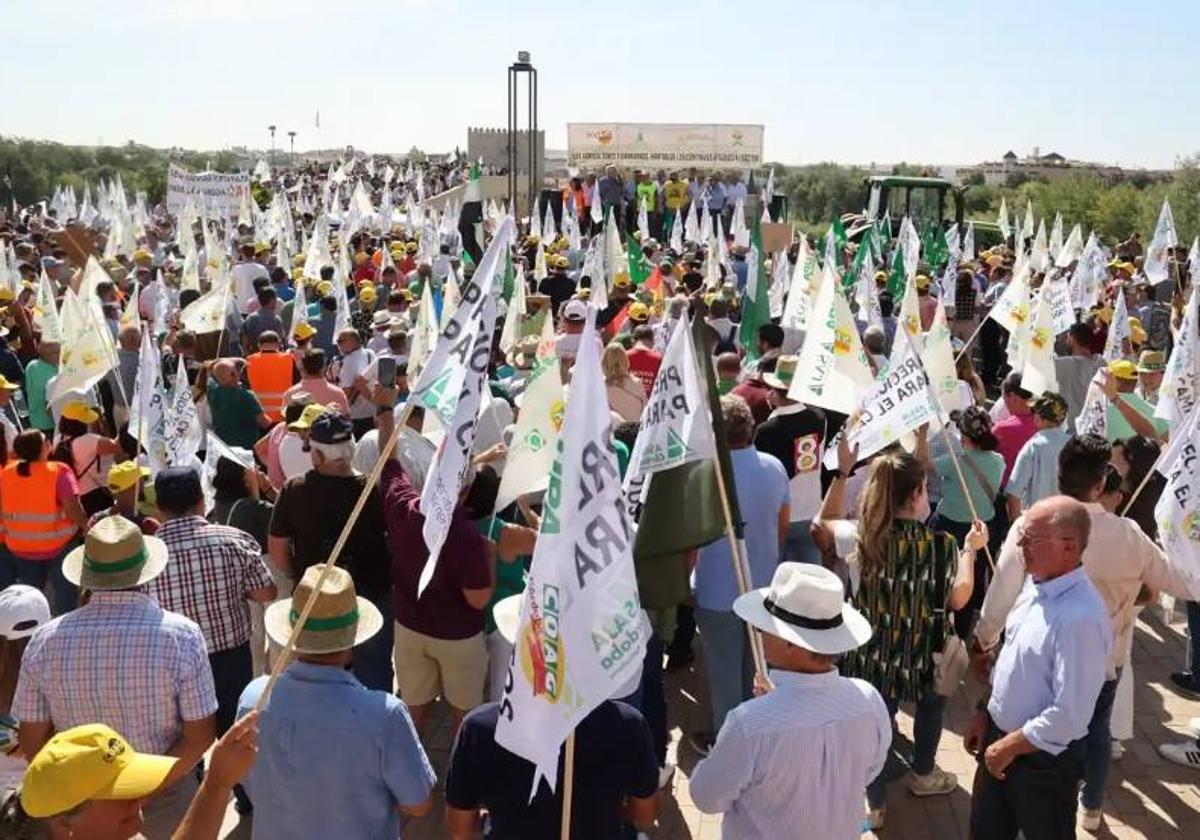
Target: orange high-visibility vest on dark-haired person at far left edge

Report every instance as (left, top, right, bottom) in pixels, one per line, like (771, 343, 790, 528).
(0, 461, 78, 557)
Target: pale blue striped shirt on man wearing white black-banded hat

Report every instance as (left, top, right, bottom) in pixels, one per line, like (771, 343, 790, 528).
(689, 670, 892, 840)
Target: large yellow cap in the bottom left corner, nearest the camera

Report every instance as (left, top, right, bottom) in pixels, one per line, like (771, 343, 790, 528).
(20, 724, 178, 818)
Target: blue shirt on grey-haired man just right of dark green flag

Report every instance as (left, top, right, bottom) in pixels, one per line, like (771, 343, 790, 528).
(692, 446, 788, 612)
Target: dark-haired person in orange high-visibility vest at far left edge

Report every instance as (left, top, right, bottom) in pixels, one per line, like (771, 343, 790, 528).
(0, 428, 88, 614)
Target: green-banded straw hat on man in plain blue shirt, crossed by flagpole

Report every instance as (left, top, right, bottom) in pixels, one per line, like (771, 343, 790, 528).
(263, 565, 383, 655)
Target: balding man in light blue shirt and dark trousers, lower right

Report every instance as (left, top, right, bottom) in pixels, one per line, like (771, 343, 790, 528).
(965, 496, 1114, 840)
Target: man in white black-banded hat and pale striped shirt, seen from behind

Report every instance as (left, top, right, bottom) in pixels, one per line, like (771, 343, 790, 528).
(690, 563, 892, 840)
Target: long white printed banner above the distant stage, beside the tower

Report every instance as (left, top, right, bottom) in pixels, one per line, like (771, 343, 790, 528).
(566, 122, 762, 169)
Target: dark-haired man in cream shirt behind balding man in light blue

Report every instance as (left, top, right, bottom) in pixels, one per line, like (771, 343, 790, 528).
(976, 434, 1190, 830)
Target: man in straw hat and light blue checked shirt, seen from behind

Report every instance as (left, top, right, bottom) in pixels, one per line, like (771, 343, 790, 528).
(12, 516, 217, 840)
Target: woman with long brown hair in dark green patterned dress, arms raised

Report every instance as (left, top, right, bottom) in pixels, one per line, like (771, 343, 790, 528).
(812, 442, 988, 828)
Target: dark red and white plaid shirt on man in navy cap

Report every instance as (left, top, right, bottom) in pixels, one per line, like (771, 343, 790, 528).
(146, 516, 274, 653)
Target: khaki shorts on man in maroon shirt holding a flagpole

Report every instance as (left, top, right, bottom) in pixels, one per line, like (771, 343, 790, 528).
(392, 622, 487, 712)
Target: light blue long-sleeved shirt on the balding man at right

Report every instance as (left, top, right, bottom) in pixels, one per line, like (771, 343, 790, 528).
(988, 566, 1112, 755)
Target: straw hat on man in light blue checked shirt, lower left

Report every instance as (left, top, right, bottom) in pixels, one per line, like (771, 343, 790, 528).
(62, 516, 167, 590)
